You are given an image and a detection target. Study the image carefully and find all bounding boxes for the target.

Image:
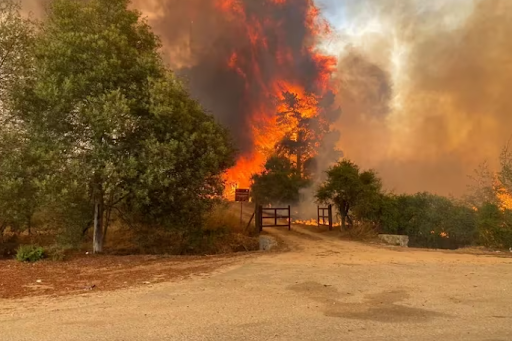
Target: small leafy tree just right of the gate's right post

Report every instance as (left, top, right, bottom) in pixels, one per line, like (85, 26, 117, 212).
(316, 160, 382, 228)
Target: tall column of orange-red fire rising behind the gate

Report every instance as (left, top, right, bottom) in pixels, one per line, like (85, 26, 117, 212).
(215, 0, 336, 196)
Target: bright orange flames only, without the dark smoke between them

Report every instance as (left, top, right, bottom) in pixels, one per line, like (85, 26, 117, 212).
(216, 0, 336, 196)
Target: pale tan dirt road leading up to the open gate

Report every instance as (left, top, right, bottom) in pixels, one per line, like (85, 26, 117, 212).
(0, 227, 512, 341)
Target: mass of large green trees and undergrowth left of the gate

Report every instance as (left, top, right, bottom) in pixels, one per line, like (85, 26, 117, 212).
(0, 0, 254, 261)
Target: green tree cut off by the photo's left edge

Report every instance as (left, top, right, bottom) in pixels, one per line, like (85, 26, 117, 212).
(0, 0, 40, 237)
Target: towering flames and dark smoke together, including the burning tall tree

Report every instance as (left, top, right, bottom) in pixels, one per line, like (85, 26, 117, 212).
(144, 0, 336, 191)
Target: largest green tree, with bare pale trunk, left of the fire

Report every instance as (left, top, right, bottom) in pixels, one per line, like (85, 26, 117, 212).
(10, 0, 233, 252)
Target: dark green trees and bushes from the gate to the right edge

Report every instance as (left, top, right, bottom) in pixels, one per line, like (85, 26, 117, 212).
(253, 148, 512, 250)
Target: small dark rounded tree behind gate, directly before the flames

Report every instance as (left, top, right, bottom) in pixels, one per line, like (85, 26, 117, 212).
(251, 156, 309, 205)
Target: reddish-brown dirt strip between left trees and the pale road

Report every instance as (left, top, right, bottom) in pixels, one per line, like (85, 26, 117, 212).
(0, 253, 255, 299)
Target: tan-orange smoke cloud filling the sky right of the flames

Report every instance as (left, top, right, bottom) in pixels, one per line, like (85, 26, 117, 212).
(328, 0, 512, 195)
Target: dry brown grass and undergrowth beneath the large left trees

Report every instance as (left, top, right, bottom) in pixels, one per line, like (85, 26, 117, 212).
(0, 204, 259, 258)
